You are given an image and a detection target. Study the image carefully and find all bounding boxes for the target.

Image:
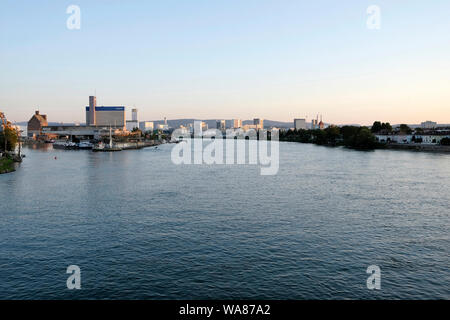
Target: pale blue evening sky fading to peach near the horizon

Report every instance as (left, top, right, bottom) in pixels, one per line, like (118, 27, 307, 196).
(0, 0, 450, 125)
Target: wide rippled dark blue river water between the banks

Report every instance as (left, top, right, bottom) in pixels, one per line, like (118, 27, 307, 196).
(0, 143, 450, 299)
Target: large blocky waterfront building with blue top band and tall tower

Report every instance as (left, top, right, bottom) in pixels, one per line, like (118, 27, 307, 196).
(86, 96, 126, 128)
